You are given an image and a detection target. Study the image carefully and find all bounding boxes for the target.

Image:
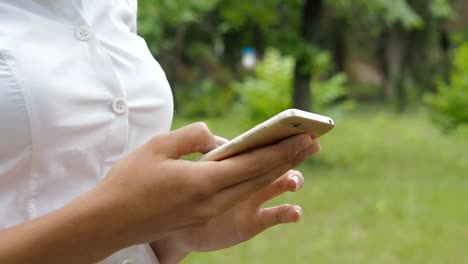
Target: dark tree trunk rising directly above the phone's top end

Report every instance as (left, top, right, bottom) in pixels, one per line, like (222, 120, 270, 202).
(293, 0, 323, 111)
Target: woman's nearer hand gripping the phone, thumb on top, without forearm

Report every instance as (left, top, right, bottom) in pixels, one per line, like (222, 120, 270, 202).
(92, 123, 314, 250)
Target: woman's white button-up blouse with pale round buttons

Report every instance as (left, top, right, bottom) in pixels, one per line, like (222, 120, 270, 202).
(0, 0, 173, 264)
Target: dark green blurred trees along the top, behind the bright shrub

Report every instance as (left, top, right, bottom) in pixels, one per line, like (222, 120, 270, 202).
(138, 0, 462, 117)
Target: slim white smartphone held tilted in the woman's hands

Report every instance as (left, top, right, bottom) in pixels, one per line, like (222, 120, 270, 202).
(195, 109, 335, 161)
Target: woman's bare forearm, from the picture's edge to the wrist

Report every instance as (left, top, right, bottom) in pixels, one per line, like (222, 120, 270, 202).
(0, 189, 124, 264)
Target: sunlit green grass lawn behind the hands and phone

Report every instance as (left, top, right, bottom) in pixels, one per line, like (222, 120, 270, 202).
(174, 108, 468, 264)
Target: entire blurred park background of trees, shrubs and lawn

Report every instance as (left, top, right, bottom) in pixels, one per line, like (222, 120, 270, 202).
(138, 0, 468, 263)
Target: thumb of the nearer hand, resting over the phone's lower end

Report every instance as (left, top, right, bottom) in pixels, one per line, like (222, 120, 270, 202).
(152, 122, 217, 159)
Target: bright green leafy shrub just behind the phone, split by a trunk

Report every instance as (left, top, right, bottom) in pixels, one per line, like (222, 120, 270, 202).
(232, 49, 350, 119)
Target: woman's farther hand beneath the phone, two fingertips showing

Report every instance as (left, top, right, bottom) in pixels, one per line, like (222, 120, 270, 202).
(151, 167, 319, 264)
